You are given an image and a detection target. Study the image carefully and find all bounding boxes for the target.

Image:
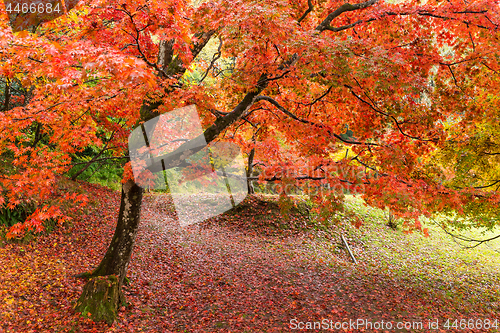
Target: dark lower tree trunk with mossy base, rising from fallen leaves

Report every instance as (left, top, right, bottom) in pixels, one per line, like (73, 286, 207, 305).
(75, 180, 143, 323)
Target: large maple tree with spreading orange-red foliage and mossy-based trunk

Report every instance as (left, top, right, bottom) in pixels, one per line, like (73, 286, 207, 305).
(0, 0, 500, 321)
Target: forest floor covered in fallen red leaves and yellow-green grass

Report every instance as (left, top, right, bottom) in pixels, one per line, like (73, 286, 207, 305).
(0, 185, 500, 333)
